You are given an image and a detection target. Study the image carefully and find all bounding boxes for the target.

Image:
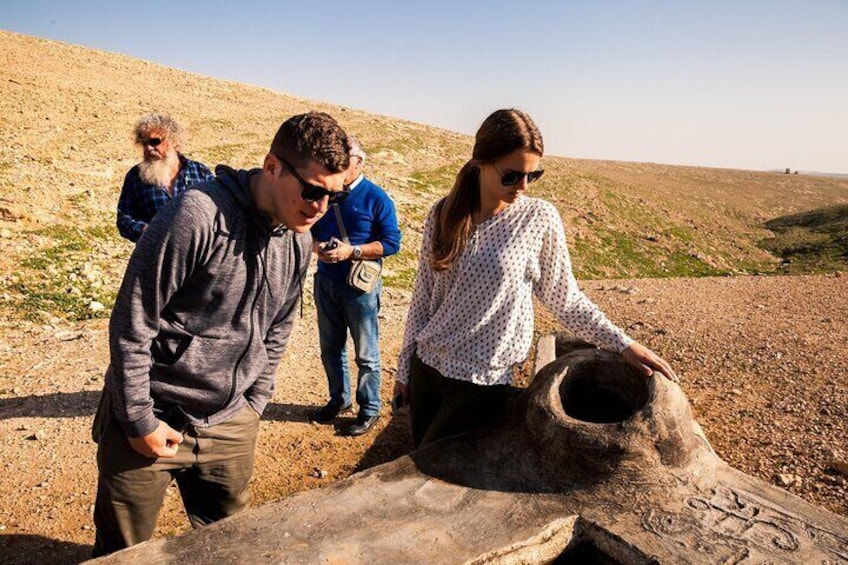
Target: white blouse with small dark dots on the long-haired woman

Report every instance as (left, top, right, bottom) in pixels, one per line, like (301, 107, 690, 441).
(396, 196, 633, 385)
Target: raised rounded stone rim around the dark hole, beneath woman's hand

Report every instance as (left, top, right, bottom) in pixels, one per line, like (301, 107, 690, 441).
(526, 340, 713, 480)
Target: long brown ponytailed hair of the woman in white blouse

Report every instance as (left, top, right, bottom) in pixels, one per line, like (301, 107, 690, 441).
(430, 108, 544, 271)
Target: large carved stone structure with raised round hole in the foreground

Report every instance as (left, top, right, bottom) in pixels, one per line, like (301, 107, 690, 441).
(93, 336, 848, 565)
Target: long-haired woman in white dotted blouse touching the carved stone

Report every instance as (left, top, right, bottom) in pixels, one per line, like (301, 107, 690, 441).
(395, 109, 677, 447)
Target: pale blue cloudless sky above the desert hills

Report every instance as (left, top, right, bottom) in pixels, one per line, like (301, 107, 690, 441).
(0, 0, 848, 173)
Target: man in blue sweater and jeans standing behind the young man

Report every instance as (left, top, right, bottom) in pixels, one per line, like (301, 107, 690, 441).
(311, 136, 401, 436)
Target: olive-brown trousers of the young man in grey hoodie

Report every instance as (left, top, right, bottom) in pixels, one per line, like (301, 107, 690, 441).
(93, 405, 259, 557)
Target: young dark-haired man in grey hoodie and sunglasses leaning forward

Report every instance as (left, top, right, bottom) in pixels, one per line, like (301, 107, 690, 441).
(92, 113, 350, 556)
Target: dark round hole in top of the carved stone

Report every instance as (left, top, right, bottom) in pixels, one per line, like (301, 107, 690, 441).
(559, 361, 648, 424)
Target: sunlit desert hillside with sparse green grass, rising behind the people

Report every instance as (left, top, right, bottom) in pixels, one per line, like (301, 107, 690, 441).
(0, 32, 848, 318)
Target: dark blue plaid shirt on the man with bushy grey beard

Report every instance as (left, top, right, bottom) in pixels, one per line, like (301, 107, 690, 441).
(117, 155, 215, 241)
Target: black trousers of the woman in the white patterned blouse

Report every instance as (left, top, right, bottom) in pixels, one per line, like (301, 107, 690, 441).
(409, 355, 509, 447)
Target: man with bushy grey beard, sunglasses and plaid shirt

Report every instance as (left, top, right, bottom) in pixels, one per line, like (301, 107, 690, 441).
(117, 114, 215, 242)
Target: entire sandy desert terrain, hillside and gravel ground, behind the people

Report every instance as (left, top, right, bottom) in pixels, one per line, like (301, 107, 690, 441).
(0, 31, 848, 563)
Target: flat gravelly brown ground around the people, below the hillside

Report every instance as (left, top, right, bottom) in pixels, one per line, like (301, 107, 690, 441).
(0, 275, 848, 563)
